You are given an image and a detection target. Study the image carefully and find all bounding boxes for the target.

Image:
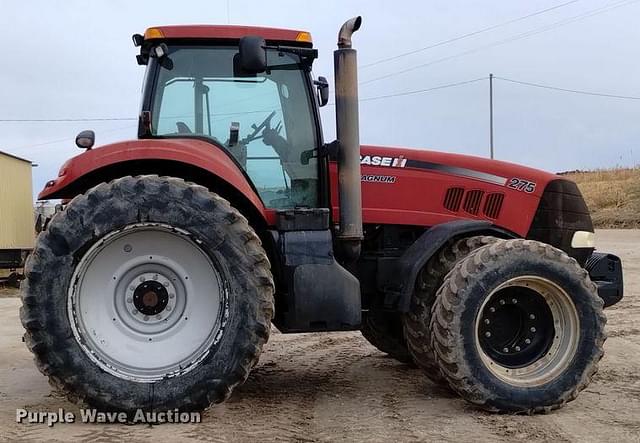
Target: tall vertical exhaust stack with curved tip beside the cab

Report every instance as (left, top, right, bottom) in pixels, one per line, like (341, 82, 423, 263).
(333, 16, 363, 261)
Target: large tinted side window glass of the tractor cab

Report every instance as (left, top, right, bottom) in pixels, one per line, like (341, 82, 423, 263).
(152, 46, 318, 208)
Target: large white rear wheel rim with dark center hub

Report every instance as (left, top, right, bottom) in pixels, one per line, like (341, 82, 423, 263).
(68, 223, 228, 382)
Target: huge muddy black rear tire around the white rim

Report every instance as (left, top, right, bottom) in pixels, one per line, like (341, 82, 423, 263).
(20, 175, 273, 415)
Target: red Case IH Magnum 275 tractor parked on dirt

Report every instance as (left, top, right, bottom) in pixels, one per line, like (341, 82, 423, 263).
(21, 17, 622, 412)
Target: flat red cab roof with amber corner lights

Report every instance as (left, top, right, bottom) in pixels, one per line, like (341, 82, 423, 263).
(144, 25, 312, 44)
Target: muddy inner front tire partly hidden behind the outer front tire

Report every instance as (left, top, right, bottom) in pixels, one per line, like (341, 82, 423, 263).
(404, 236, 498, 384)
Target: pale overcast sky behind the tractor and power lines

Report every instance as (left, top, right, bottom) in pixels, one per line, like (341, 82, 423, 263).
(0, 0, 640, 198)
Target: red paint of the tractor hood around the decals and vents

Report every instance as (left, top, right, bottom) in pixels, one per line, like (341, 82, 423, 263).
(330, 146, 558, 236)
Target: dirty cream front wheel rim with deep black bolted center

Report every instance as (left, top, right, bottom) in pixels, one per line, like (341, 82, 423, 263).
(475, 275, 580, 387)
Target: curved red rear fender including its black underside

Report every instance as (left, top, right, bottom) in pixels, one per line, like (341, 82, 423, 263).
(38, 138, 275, 225)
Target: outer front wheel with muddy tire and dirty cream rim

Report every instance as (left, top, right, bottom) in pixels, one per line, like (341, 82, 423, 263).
(431, 239, 606, 413)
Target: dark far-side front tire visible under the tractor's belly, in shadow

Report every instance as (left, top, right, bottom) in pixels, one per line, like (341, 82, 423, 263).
(361, 311, 412, 363)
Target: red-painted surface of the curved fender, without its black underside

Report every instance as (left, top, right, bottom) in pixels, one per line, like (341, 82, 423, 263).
(38, 139, 275, 225)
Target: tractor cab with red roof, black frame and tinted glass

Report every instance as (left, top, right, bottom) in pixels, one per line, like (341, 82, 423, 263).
(134, 26, 326, 209)
